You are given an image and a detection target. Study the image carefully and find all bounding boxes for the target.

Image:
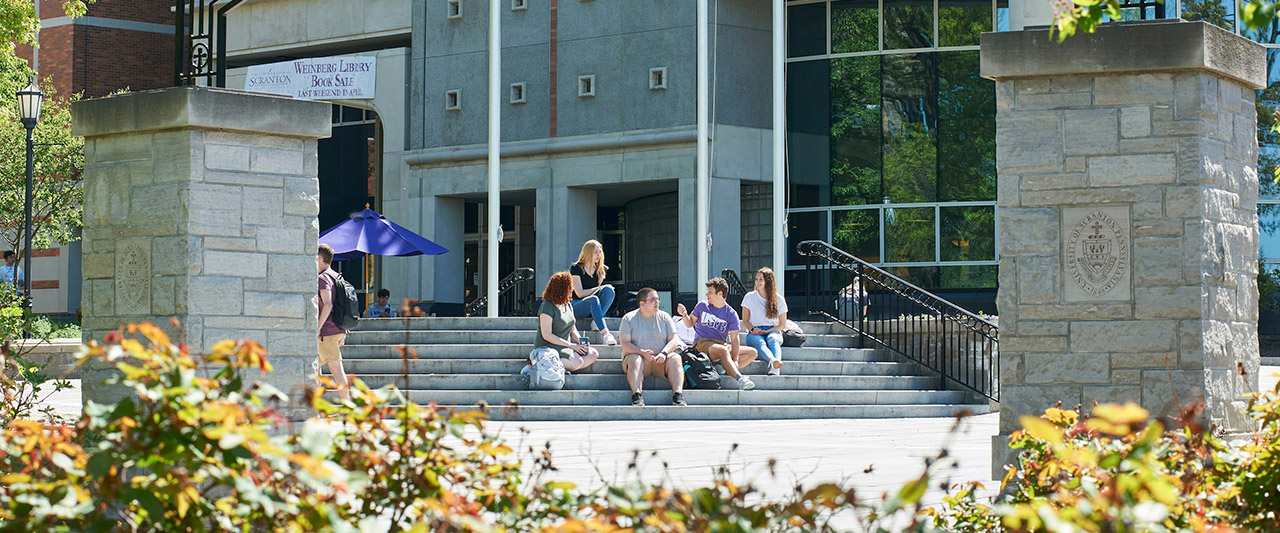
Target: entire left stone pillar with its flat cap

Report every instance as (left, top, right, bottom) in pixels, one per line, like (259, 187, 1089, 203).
(72, 87, 330, 415)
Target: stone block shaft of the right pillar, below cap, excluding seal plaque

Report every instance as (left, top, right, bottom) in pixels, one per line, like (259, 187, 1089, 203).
(996, 72, 1258, 433)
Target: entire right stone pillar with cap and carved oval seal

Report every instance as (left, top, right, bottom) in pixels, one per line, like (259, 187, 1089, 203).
(982, 22, 1266, 479)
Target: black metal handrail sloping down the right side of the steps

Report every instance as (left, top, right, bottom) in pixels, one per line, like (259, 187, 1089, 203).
(796, 241, 1000, 401)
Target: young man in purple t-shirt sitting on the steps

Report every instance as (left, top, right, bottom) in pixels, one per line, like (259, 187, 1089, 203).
(676, 278, 758, 391)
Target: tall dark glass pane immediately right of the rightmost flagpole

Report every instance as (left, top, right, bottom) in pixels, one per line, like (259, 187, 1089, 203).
(787, 59, 832, 208)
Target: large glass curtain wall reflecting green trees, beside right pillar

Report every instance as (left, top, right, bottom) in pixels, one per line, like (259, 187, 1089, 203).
(787, 0, 1007, 292)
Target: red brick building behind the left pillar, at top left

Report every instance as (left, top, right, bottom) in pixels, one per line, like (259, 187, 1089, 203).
(18, 0, 174, 97)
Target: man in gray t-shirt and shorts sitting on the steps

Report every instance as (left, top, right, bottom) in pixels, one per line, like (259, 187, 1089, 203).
(618, 287, 687, 406)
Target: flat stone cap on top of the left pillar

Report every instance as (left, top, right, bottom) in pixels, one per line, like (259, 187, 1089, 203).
(72, 87, 333, 138)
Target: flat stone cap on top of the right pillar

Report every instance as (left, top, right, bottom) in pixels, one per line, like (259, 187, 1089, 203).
(982, 21, 1267, 90)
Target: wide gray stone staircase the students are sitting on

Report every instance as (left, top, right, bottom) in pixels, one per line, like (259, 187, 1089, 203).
(326, 318, 989, 420)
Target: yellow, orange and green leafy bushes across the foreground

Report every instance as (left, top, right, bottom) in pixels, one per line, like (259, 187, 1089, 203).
(0, 324, 1280, 532)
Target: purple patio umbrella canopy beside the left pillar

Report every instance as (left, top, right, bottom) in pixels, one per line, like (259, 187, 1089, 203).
(320, 208, 448, 261)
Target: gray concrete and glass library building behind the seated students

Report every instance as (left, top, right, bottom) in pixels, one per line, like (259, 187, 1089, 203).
(202, 0, 1280, 314)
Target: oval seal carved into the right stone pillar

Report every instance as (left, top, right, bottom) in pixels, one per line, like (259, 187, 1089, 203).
(1066, 211, 1129, 296)
